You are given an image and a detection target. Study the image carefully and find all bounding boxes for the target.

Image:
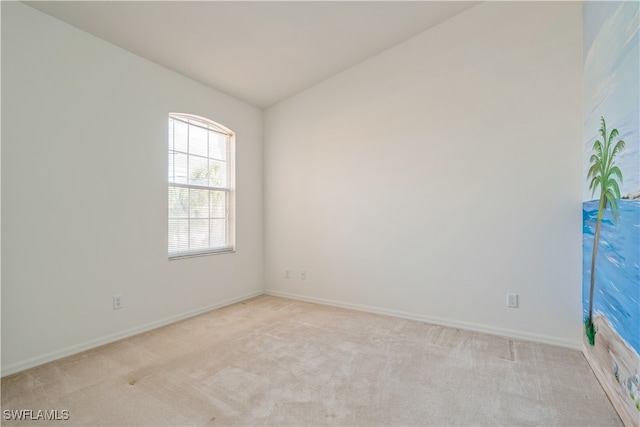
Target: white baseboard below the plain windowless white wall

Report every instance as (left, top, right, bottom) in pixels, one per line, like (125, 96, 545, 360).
(264, 290, 582, 351)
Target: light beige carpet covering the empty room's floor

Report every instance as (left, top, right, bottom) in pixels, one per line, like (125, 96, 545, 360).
(2, 296, 621, 426)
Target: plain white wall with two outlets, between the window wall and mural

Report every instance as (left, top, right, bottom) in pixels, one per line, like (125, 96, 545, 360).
(265, 2, 582, 348)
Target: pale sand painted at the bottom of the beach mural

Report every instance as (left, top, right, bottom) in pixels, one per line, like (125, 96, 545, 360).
(585, 314, 640, 426)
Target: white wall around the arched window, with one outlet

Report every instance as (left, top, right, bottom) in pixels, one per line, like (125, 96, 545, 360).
(2, 2, 263, 375)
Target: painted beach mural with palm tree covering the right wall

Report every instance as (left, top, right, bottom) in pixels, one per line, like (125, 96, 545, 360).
(582, 1, 640, 426)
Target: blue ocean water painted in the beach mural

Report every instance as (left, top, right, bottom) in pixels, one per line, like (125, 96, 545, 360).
(582, 199, 640, 354)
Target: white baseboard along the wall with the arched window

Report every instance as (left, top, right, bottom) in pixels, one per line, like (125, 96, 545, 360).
(2, 290, 264, 377)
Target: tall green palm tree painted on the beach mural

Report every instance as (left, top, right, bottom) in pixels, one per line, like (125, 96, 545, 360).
(585, 117, 625, 345)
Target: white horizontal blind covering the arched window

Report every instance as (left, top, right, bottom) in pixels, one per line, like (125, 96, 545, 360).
(168, 114, 233, 258)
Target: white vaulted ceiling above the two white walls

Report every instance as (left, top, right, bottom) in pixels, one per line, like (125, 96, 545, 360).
(25, 1, 477, 108)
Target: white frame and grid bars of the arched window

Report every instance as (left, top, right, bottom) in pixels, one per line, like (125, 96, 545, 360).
(167, 113, 235, 260)
